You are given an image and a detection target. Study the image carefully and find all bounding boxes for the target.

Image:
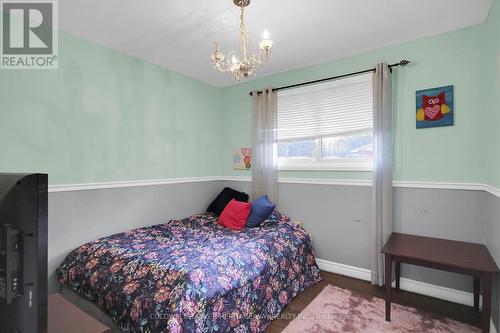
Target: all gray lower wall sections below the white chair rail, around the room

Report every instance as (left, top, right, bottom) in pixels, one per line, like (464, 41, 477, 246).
(48, 181, 500, 327)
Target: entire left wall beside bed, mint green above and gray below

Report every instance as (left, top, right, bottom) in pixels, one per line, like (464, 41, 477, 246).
(0, 32, 222, 291)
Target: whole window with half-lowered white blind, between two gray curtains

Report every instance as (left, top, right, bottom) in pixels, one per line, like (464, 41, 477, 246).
(278, 74, 373, 171)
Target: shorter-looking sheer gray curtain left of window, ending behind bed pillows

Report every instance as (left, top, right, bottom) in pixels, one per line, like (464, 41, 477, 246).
(252, 88, 278, 203)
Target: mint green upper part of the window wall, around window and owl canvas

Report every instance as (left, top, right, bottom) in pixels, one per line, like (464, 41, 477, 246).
(222, 18, 492, 182)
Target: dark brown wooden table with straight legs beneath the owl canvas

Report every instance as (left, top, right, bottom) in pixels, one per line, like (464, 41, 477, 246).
(382, 233, 498, 333)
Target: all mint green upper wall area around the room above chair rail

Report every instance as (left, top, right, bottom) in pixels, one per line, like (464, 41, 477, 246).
(0, 5, 500, 187)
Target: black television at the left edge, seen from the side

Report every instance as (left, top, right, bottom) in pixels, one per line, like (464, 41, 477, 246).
(0, 173, 47, 333)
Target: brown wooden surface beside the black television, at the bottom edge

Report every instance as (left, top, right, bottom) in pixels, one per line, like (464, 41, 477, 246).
(47, 294, 111, 333)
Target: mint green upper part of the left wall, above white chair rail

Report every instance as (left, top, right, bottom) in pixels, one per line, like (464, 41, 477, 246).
(0, 33, 222, 184)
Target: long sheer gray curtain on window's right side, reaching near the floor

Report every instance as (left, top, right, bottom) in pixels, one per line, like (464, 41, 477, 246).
(371, 64, 393, 286)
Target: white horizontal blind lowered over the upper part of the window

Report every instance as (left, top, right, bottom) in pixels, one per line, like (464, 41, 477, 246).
(277, 73, 373, 141)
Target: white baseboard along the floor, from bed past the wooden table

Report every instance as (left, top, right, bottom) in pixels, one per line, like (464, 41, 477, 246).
(316, 259, 497, 333)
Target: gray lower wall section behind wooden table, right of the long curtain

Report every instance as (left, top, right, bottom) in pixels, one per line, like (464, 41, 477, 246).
(394, 188, 484, 292)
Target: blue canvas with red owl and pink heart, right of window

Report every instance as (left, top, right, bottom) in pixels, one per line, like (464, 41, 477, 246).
(416, 86, 454, 128)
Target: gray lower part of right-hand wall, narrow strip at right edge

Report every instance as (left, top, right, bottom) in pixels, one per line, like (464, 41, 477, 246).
(483, 192, 500, 331)
